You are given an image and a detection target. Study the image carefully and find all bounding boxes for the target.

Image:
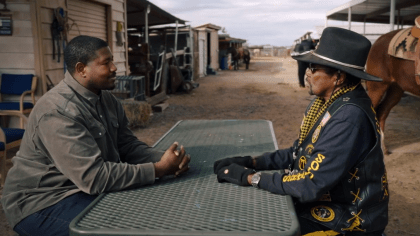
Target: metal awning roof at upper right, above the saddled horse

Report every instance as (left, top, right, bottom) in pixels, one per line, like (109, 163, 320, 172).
(327, 0, 420, 25)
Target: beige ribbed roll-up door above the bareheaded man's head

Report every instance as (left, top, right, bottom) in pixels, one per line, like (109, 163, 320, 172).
(67, 0, 107, 43)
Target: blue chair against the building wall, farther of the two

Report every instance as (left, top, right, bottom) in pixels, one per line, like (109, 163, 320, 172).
(0, 74, 37, 128)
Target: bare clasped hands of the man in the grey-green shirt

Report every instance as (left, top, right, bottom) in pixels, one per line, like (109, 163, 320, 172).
(154, 142, 191, 177)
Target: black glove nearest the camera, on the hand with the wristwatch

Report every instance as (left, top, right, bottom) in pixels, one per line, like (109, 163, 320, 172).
(217, 163, 255, 186)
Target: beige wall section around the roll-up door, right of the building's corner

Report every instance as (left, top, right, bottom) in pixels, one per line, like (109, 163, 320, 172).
(36, 0, 128, 90)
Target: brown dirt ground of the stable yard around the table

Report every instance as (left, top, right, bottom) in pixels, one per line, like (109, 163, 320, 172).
(0, 57, 420, 236)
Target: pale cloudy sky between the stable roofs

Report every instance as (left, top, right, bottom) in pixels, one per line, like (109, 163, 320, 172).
(149, 0, 350, 46)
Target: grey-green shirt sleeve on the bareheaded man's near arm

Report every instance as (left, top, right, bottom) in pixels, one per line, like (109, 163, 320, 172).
(32, 110, 155, 194)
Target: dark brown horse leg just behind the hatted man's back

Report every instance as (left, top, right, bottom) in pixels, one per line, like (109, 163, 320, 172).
(376, 83, 404, 155)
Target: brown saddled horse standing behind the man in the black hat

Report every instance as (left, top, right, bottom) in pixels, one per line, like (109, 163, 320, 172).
(366, 30, 420, 154)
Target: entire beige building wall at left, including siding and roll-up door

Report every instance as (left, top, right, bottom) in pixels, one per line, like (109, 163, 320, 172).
(0, 0, 128, 127)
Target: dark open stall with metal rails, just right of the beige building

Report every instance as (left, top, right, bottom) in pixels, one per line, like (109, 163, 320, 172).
(127, 0, 194, 105)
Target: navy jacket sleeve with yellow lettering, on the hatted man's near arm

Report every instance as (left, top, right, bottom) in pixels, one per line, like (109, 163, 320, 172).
(259, 105, 375, 202)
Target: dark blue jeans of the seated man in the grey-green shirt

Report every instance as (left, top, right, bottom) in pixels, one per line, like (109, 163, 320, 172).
(13, 192, 97, 236)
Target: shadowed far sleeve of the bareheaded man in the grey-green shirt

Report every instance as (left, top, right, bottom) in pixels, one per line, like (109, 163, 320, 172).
(115, 97, 164, 164)
